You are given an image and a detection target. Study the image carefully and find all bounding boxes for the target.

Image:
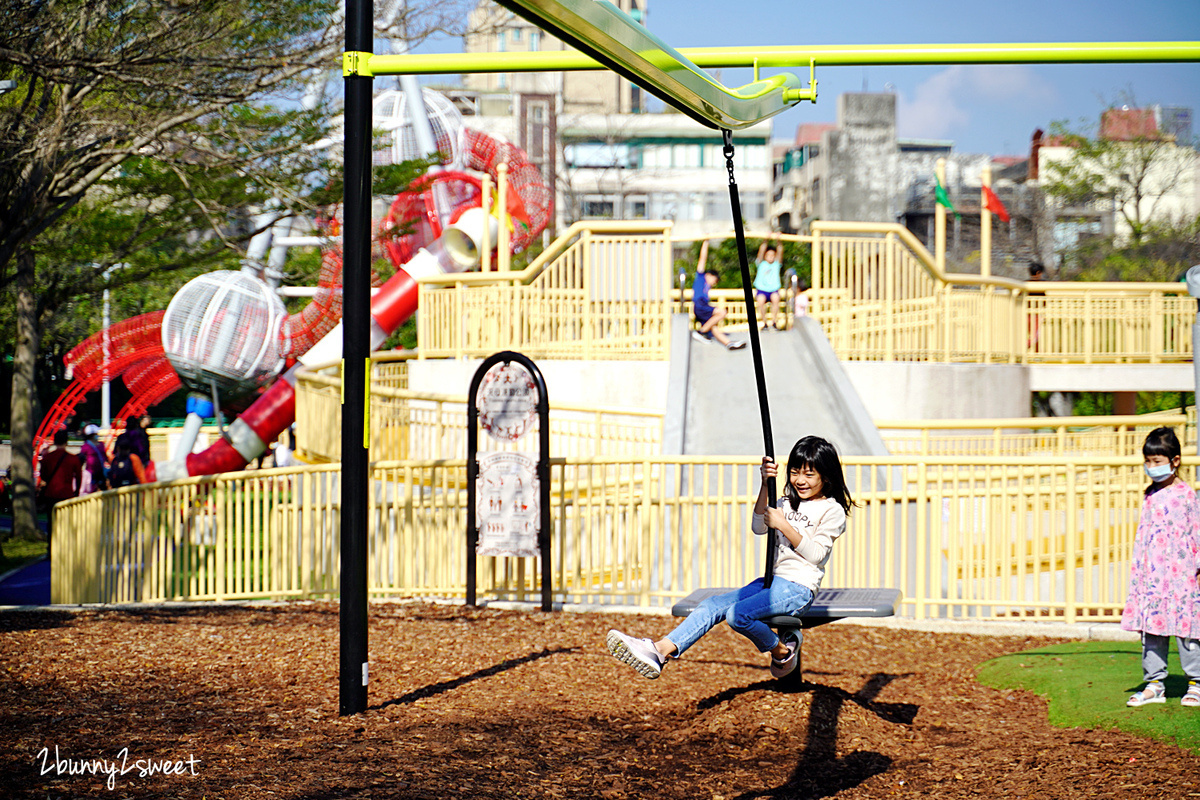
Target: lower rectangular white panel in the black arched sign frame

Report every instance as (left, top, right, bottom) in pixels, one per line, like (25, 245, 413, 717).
(475, 452, 541, 557)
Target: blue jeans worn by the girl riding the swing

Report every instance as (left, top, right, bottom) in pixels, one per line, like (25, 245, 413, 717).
(666, 578, 812, 656)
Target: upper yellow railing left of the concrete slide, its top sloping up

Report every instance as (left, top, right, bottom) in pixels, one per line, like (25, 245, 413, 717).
(418, 222, 672, 360)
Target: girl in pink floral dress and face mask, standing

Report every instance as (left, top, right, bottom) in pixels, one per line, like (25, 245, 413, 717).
(1121, 427, 1200, 708)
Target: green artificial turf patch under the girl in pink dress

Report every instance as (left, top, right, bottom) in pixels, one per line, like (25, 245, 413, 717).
(976, 637, 1200, 753)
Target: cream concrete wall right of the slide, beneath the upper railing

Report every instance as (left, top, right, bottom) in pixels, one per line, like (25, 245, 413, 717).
(841, 361, 1032, 421)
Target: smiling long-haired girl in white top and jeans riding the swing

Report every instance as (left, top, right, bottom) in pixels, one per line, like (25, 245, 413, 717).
(606, 437, 854, 678)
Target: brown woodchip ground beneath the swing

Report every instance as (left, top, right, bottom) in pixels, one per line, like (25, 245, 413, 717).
(0, 603, 1200, 800)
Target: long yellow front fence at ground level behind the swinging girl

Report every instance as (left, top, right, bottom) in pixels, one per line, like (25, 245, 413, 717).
(52, 456, 1171, 621)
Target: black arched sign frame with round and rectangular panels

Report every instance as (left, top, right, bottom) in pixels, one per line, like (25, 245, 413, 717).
(467, 350, 552, 612)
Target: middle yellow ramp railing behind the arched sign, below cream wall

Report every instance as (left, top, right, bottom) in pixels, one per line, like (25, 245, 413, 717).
(295, 361, 664, 463)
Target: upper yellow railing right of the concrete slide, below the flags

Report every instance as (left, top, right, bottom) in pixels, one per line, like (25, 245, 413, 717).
(810, 222, 1195, 363)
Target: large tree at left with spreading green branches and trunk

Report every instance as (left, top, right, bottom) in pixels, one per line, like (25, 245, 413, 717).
(0, 0, 341, 534)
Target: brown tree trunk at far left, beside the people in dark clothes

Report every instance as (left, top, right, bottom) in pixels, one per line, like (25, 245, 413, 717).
(11, 247, 41, 539)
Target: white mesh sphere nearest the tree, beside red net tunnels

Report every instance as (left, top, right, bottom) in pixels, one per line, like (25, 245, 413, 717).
(162, 270, 288, 395)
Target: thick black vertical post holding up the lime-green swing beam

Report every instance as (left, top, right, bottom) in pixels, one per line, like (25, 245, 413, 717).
(338, 0, 374, 716)
